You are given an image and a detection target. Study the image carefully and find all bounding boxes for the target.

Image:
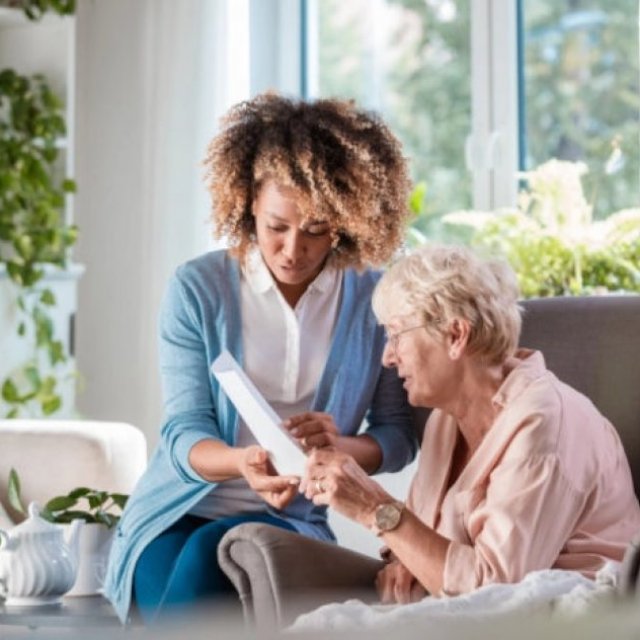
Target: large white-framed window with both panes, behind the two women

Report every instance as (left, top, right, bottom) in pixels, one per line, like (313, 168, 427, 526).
(302, 0, 640, 225)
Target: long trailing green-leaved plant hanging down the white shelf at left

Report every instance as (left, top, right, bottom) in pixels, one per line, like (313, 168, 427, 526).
(0, 62, 77, 417)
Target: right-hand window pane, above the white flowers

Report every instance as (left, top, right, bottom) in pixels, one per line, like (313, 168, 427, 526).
(522, 0, 640, 218)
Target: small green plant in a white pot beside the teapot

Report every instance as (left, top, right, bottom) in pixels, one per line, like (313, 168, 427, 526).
(7, 469, 128, 596)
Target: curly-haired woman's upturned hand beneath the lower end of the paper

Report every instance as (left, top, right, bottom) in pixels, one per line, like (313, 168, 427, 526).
(239, 445, 300, 509)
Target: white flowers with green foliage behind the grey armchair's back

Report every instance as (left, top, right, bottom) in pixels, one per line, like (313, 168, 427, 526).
(443, 159, 640, 298)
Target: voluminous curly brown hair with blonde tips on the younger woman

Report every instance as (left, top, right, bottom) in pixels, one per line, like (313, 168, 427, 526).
(204, 92, 410, 268)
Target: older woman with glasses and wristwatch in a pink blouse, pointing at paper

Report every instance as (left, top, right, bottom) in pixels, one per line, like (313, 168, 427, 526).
(301, 246, 640, 603)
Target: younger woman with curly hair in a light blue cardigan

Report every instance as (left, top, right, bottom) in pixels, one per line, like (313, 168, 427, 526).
(105, 94, 418, 621)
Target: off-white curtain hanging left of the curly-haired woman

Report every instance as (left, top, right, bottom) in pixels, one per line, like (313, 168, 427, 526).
(75, 0, 227, 445)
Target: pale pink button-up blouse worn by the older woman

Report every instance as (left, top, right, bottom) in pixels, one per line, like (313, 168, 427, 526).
(408, 349, 640, 594)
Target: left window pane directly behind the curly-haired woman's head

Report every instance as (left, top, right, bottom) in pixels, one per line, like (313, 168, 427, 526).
(309, 0, 472, 237)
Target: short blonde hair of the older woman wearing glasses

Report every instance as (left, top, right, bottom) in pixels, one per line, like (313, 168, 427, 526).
(373, 244, 522, 364)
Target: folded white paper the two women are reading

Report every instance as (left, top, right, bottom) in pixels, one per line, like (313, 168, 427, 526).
(211, 351, 307, 476)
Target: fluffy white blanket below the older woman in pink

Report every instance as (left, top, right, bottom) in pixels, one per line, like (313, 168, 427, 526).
(289, 562, 619, 632)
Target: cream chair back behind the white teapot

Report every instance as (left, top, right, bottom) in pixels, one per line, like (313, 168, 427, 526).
(0, 420, 147, 527)
